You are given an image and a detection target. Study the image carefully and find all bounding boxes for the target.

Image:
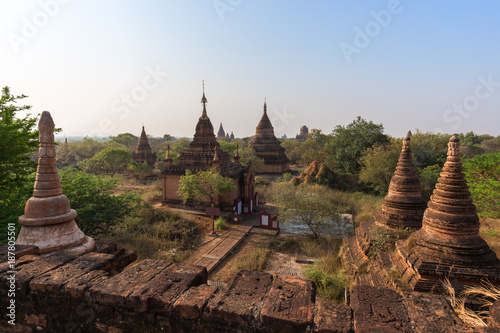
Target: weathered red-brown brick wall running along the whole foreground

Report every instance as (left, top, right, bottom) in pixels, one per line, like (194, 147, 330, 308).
(0, 244, 495, 332)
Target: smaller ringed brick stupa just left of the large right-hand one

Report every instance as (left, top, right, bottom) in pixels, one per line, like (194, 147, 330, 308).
(375, 131, 426, 229)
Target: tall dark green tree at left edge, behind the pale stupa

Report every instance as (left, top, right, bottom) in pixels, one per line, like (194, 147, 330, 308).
(0, 87, 38, 241)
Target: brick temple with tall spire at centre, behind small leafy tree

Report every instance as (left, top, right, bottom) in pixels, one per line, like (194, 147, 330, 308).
(161, 85, 255, 210)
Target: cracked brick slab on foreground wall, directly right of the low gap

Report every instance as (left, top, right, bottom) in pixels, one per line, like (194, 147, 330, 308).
(351, 285, 413, 333)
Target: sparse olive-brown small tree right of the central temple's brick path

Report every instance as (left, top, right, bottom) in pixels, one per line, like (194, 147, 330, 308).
(271, 183, 341, 239)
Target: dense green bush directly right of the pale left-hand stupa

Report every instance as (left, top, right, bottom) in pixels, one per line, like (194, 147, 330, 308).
(59, 168, 141, 235)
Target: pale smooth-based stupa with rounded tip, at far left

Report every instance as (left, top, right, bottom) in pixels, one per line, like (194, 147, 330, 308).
(16, 111, 94, 254)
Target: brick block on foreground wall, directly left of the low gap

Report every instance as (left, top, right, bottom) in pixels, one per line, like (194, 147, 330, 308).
(261, 275, 316, 332)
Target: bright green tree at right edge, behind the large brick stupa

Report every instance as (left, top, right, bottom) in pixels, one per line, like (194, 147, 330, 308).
(463, 153, 500, 219)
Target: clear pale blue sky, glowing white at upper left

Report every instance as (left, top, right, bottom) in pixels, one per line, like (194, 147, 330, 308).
(0, 0, 500, 137)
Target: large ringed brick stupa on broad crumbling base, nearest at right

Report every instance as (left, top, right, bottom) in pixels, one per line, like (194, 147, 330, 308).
(396, 136, 500, 291)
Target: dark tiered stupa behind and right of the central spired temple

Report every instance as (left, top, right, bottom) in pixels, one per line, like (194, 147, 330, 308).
(248, 102, 290, 173)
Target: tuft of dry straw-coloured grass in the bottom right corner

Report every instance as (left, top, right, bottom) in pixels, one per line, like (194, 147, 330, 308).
(443, 279, 500, 327)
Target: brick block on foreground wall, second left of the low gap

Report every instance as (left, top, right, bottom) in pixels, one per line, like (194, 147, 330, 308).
(207, 270, 272, 325)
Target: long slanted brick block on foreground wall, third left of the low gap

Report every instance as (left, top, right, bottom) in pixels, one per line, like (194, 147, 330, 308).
(130, 263, 208, 313)
